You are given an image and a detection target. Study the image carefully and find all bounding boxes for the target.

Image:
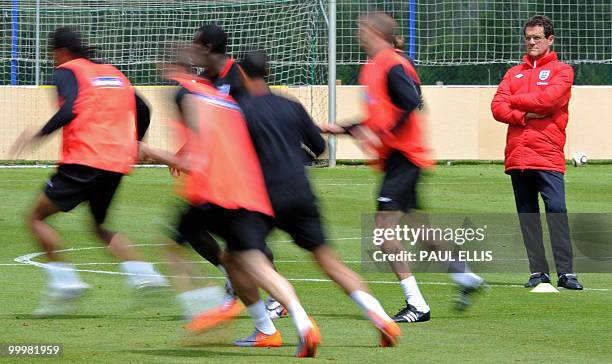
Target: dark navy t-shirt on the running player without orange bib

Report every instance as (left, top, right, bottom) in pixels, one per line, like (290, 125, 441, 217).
(240, 94, 325, 191)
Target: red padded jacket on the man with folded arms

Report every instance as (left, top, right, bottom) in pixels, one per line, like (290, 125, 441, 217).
(491, 52, 574, 173)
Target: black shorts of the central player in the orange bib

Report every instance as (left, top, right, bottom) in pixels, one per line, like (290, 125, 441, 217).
(175, 204, 271, 252)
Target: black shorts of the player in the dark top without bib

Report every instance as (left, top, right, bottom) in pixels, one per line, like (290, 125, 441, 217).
(268, 182, 325, 251)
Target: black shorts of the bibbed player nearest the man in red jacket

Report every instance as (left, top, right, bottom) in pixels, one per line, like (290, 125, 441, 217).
(377, 151, 421, 213)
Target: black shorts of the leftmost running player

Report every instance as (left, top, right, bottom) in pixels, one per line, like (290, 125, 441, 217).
(44, 164, 123, 225)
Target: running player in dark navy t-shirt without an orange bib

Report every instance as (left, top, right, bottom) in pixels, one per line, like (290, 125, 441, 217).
(218, 52, 400, 347)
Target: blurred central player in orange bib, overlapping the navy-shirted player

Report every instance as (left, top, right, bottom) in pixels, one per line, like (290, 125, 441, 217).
(143, 69, 321, 357)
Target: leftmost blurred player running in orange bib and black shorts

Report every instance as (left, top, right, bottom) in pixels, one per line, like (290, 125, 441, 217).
(13, 28, 167, 315)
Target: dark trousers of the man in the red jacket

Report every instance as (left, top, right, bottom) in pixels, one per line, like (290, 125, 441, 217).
(510, 170, 573, 274)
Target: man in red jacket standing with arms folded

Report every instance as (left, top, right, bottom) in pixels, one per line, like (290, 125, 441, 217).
(491, 15, 582, 290)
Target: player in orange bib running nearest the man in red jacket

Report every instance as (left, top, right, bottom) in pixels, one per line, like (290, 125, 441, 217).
(321, 12, 483, 322)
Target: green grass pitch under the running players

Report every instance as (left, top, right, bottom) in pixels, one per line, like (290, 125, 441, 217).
(0, 165, 612, 363)
